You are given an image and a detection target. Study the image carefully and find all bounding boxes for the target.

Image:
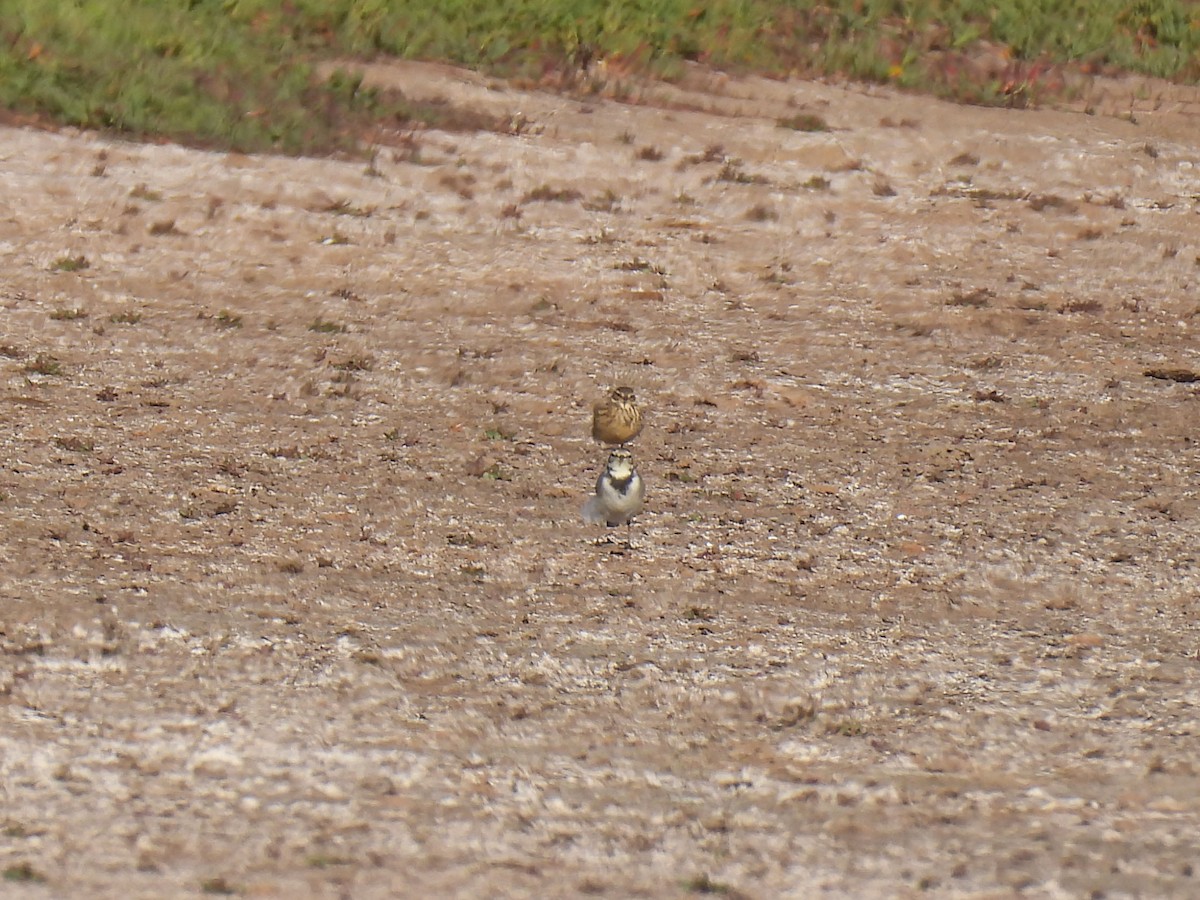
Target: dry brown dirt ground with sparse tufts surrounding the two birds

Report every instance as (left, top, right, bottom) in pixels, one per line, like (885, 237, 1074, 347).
(0, 65, 1200, 900)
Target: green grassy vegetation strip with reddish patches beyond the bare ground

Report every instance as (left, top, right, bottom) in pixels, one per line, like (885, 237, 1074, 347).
(0, 0, 1200, 154)
